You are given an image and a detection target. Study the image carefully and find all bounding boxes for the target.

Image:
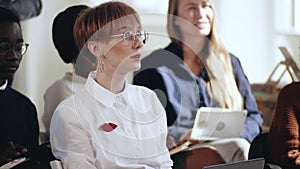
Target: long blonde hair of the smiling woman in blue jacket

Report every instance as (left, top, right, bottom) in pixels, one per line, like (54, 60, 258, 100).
(167, 0, 244, 110)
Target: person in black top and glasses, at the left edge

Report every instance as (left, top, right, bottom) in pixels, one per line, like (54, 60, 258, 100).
(0, 7, 39, 166)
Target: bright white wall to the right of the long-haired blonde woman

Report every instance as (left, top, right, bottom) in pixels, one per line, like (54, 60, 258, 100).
(213, 0, 300, 85)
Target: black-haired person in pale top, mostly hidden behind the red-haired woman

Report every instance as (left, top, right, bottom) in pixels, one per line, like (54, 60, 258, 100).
(42, 5, 97, 141)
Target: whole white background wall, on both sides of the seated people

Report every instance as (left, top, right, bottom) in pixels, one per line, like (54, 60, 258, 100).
(13, 0, 299, 130)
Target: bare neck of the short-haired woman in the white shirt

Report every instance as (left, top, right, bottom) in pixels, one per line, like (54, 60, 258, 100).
(95, 70, 126, 94)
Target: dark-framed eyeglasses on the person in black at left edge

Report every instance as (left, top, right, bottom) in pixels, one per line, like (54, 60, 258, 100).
(0, 42, 29, 56)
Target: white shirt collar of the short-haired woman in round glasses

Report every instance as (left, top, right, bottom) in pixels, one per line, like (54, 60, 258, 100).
(85, 71, 129, 107)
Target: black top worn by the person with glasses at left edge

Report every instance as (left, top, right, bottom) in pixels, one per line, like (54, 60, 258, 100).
(0, 87, 39, 152)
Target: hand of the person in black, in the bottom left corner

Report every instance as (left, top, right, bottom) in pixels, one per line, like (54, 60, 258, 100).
(0, 142, 27, 166)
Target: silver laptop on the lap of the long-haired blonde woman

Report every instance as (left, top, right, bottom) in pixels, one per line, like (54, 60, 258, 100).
(191, 107, 247, 142)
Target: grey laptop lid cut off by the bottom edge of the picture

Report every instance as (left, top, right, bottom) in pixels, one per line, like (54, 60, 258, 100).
(202, 158, 265, 169)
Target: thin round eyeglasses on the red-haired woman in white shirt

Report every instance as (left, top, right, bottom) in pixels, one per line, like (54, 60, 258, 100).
(111, 31, 149, 45)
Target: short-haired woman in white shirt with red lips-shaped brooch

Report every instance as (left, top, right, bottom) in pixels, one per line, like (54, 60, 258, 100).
(50, 1, 172, 169)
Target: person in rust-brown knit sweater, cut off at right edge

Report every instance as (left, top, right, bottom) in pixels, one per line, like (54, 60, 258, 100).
(267, 82, 300, 169)
